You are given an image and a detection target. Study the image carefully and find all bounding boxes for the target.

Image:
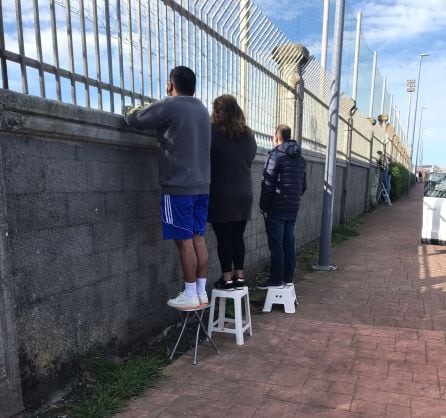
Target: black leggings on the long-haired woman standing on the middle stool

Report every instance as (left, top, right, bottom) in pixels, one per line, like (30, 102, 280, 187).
(212, 221, 246, 273)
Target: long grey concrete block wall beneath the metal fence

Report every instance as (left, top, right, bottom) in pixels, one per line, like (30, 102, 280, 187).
(0, 91, 367, 401)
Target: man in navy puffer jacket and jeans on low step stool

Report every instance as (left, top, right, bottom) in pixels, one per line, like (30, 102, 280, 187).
(258, 125, 307, 289)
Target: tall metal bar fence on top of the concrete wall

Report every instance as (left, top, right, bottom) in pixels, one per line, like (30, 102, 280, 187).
(0, 0, 410, 166)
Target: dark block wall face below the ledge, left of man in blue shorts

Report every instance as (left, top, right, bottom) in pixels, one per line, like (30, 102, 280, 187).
(0, 135, 186, 402)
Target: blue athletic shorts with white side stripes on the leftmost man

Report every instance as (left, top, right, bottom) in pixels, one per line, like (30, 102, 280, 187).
(161, 194, 209, 239)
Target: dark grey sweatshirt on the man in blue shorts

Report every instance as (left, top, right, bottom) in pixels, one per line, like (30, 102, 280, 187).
(125, 96, 211, 195)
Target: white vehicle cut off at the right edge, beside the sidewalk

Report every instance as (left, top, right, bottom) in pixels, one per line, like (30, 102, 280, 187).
(421, 173, 446, 245)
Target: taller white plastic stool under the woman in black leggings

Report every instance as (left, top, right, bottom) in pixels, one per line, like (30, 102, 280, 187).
(208, 286, 252, 345)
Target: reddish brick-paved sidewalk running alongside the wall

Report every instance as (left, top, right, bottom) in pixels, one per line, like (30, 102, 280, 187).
(119, 186, 446, 418)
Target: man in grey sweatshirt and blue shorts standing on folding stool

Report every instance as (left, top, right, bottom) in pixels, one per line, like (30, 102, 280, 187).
(125, 66, 211, 309)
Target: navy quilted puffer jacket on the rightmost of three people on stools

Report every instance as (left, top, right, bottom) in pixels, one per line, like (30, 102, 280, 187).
(259, 140, 307, 214)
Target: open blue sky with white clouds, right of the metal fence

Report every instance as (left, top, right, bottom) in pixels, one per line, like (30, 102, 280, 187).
(255, 0, 446, 168)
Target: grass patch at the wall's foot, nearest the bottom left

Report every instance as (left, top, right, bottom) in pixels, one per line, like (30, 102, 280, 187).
(37, 318, 217, 418)
